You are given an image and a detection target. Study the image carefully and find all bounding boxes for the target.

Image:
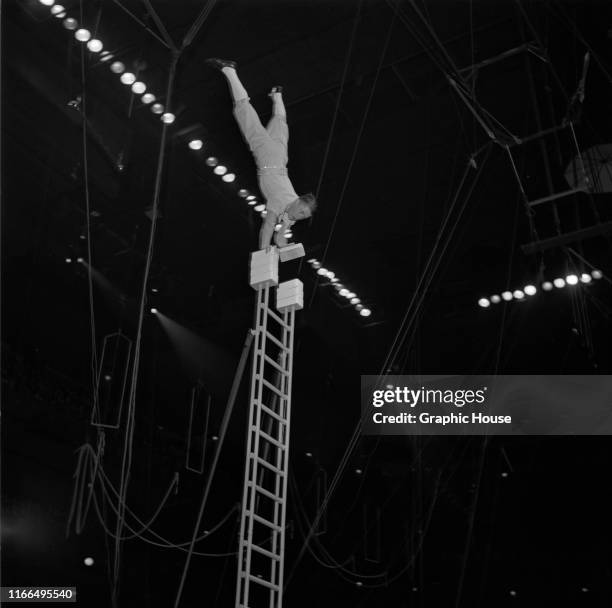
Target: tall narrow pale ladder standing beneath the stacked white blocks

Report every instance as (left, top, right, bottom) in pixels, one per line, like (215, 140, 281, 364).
(235, 285, 295, 608)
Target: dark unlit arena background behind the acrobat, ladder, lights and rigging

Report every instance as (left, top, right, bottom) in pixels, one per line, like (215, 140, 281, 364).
(2, 0, 612, 607)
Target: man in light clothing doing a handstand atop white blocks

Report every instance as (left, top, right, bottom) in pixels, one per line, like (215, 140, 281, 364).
(207, 59, 317, 249)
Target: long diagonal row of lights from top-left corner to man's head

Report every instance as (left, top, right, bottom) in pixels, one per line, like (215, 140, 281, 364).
(39, 0, 270, 226)
